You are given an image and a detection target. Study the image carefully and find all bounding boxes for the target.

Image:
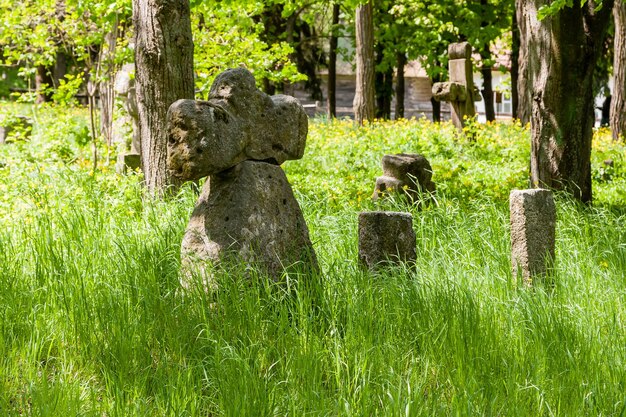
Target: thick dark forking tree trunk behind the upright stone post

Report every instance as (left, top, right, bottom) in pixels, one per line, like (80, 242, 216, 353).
(518, 0, 613, 203)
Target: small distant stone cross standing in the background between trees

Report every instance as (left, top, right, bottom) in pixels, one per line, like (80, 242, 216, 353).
(432, 42, 480, 130)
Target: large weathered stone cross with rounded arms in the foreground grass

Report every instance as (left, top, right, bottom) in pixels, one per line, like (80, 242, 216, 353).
(167, 68, 318, 287)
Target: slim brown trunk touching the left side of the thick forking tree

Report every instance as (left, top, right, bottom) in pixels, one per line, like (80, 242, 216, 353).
(514, 0, 528, 124)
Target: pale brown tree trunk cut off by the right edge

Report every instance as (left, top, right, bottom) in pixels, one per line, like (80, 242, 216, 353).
(610, 0, 626, 140)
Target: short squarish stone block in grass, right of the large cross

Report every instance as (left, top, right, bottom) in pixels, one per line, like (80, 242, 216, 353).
(359, 211, 417, 269)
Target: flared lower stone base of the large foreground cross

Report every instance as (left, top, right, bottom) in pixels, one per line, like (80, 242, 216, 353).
(182, 161, 318, 288)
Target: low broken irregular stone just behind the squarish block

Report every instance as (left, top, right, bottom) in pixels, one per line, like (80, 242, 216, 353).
(372, 154, 435, 201)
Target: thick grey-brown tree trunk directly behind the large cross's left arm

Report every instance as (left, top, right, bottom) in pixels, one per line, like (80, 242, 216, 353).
(133, 0, 194, 196)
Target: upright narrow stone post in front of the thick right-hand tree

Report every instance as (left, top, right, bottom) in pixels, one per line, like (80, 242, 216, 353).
(509, 189, 556, 285)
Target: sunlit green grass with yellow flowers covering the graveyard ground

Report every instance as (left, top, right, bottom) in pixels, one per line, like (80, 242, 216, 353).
(0, 102, 626, 416)
